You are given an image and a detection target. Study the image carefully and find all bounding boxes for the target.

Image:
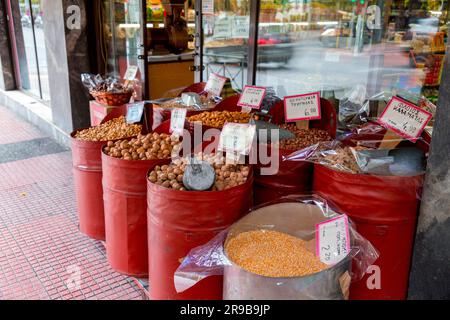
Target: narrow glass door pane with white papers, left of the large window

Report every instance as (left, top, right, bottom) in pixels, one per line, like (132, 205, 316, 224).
(203, 0, 250, 90)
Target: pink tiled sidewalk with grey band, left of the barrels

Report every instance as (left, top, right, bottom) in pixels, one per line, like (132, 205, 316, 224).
(0, 106, 145, 300)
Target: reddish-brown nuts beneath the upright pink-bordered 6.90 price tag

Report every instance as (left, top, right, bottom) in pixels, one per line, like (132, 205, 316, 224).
(279, 124, 331, 150)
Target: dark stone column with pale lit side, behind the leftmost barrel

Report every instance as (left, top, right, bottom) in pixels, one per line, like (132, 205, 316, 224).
(41, 0, 91, 133)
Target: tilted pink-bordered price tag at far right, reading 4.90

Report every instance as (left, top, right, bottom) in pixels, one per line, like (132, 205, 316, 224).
(378, 97, 432, 142)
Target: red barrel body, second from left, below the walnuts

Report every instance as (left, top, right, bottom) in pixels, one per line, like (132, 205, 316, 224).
(102, 152, 170, 277)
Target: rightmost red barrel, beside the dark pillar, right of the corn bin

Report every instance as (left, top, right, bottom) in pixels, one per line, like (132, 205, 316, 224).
(313, 165, 424, 299)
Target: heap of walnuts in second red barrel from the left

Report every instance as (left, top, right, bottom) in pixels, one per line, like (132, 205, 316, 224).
(105, 132, 181, 160)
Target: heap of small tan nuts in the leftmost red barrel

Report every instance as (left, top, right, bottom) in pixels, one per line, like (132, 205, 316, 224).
(75, 116, 142, 141)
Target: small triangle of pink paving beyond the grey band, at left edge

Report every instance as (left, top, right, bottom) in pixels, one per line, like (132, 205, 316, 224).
(0, 106, 44, 144)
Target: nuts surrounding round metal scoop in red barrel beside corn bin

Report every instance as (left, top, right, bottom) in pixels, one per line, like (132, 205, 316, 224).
(148, 153, 250, 191)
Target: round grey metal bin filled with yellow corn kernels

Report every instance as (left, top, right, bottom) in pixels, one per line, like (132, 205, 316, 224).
(223, 202, 351, 300)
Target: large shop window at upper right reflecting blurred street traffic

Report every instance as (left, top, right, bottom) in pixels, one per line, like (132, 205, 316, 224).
(257, 0, 449, 107)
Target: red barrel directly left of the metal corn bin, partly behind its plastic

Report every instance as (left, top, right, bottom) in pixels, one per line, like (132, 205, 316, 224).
(147, 168, 253, 300)
